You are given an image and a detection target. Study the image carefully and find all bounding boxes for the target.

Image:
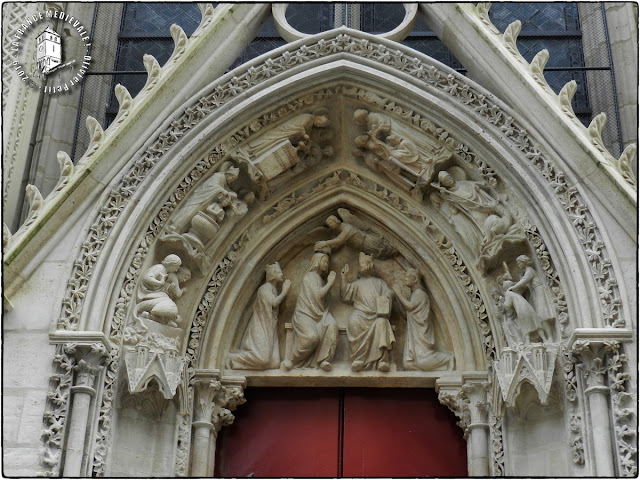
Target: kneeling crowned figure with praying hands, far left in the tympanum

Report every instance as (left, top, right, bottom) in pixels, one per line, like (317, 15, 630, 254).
(227, 262, 291, 370)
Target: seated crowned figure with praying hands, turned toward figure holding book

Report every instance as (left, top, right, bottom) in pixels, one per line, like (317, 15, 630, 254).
(282, 252, 338, 371)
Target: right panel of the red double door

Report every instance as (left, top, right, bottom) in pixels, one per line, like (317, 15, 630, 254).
(342, 388, 467, 477)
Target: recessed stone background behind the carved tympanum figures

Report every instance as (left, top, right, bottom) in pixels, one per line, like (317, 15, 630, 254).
(225, 208, 455, 378)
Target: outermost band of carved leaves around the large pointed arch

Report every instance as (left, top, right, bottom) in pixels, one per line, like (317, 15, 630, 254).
(22, 29, 624, 476)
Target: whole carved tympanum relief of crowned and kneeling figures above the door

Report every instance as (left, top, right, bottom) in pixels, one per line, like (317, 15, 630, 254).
(226, 208, 455, 374)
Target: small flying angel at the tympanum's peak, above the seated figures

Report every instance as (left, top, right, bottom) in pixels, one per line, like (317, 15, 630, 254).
(315, 208, 398, 260)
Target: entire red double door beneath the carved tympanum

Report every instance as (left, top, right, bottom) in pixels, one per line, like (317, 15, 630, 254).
(215, 388, 467, 477)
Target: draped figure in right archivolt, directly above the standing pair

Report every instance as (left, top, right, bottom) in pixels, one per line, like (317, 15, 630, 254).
(431, 170, 526, 270)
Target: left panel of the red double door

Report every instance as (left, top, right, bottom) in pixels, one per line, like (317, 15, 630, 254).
(215, 388, 339, 477)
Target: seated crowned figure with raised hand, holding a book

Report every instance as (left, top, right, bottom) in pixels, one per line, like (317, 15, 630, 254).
(340, 252, 396, 372)
